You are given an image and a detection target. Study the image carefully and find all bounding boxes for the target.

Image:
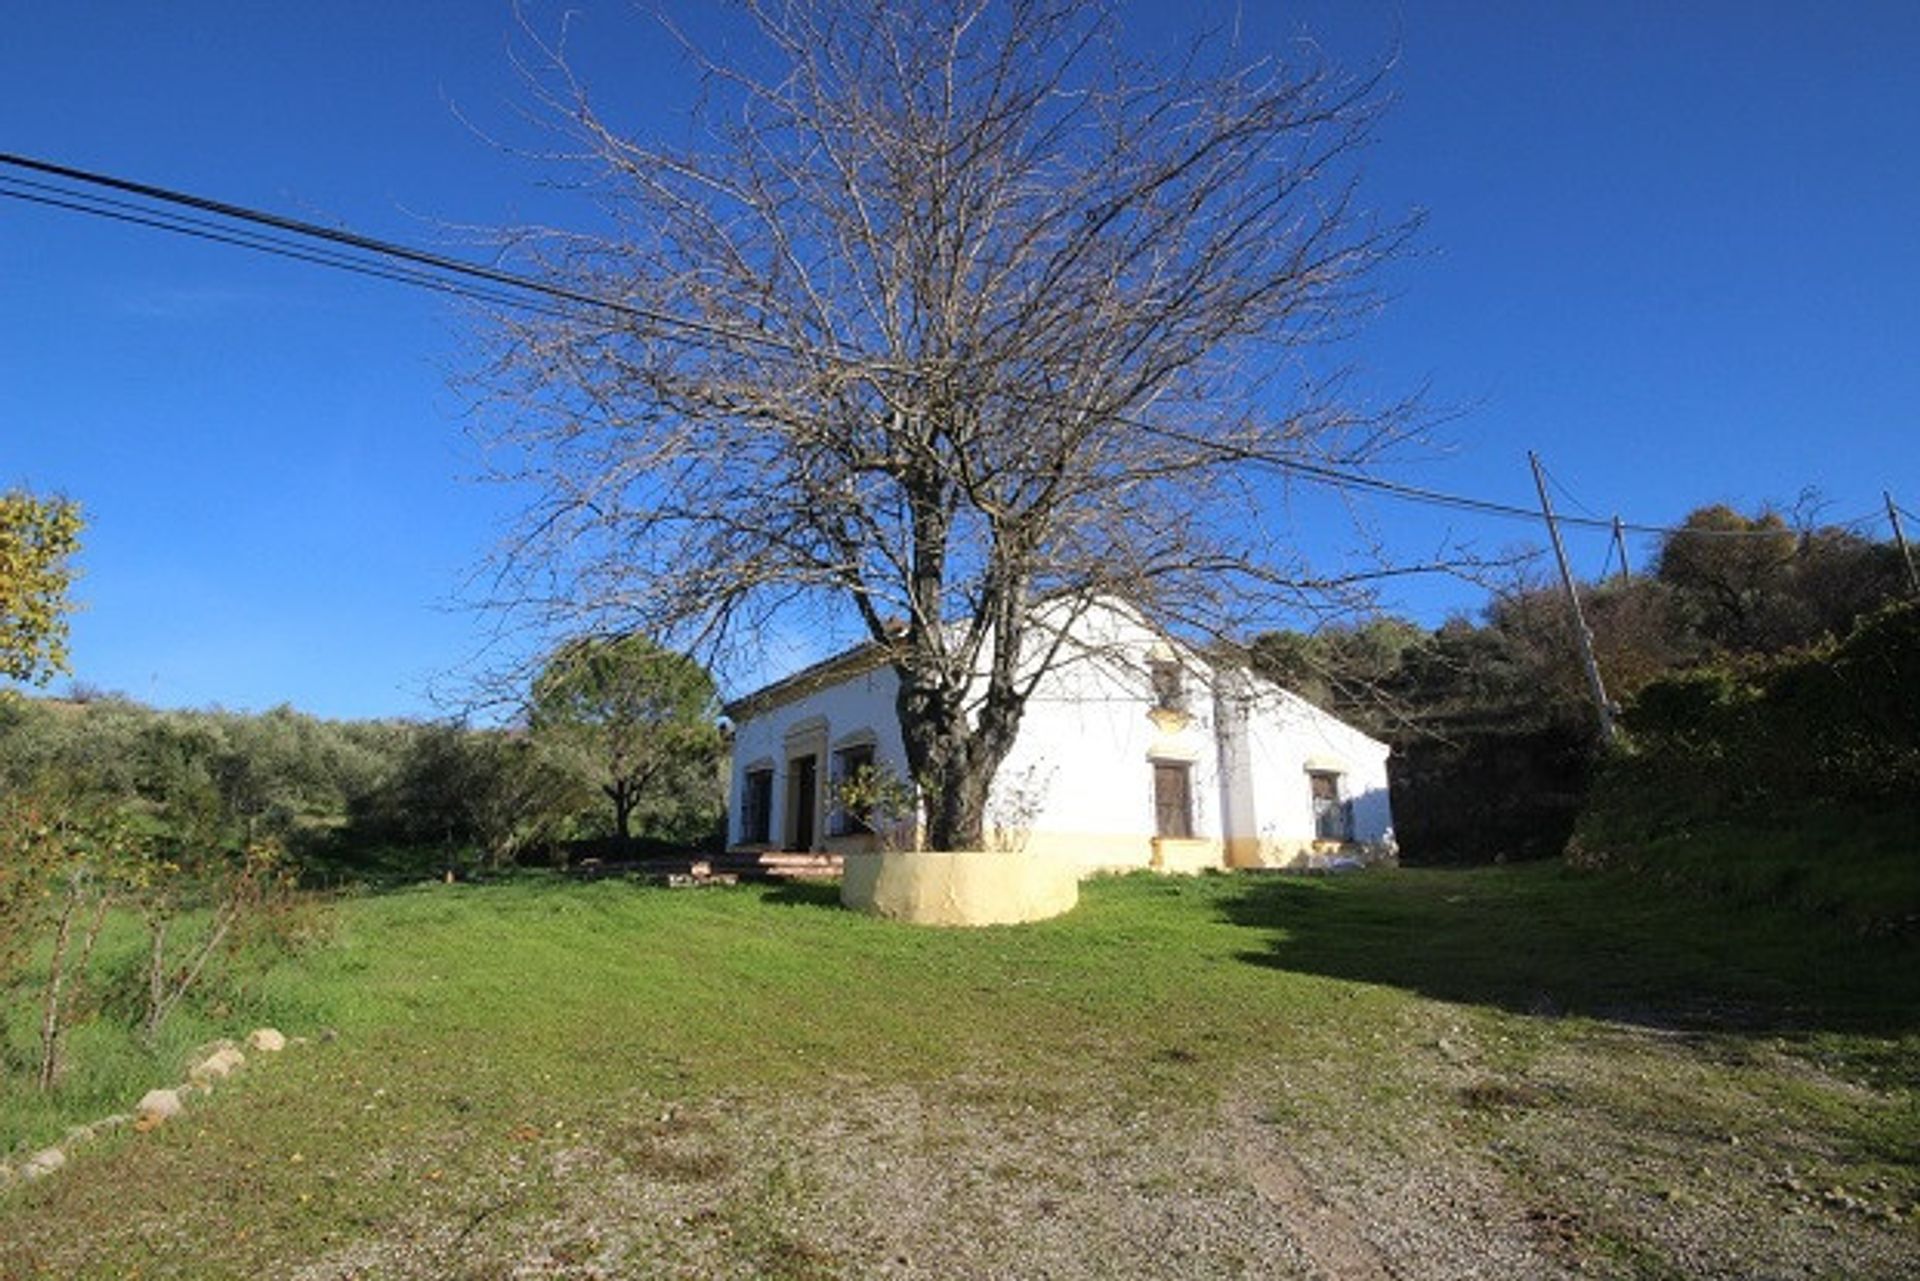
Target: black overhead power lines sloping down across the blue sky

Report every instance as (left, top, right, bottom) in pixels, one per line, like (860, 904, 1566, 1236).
(0, 152, 1910, 538)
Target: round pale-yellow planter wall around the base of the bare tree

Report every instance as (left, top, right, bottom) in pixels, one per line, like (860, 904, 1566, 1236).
(841, 849, 1079, 926)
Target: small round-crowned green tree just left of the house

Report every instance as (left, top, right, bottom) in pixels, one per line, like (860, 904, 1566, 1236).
(530, 636, 720, 841)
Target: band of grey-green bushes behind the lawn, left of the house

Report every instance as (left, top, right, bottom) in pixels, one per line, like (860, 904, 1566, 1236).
(0, 695, 645, 880)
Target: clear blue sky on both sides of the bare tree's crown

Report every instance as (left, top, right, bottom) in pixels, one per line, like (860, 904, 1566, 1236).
(0, 0, 1920, 716)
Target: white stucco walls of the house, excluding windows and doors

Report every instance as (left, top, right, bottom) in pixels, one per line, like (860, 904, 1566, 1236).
(728, 595, 1392, 872)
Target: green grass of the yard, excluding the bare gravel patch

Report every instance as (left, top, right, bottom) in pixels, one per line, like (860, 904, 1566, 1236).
(0, 864, 1920, 1275)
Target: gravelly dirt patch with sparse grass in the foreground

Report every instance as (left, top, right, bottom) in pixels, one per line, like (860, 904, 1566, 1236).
(274, 1056, 1920, 1281)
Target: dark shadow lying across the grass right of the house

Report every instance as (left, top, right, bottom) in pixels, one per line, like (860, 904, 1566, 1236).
(1221, 862, 1920, 1037)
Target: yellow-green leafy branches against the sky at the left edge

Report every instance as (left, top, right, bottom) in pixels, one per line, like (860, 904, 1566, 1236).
(0, 490, 84, 686)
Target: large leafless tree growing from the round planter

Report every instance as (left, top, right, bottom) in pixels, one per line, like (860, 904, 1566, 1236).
(472, 0, 1411, 849)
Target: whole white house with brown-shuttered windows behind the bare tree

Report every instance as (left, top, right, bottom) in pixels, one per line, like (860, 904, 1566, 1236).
(728, 599, 1394, 872)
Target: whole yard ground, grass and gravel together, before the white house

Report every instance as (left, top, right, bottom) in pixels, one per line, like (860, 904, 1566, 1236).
(0, 864, 1920, 1277)
